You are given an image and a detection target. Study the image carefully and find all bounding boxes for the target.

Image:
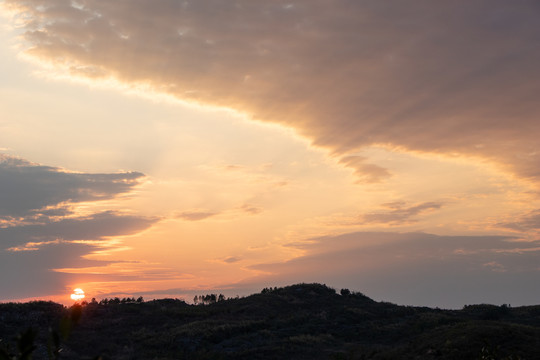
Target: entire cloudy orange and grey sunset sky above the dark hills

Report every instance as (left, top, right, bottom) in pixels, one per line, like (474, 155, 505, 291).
(0, 0, 540, 308)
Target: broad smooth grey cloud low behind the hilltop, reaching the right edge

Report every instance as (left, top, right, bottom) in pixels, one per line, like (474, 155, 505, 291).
(245, 232, 540, 308)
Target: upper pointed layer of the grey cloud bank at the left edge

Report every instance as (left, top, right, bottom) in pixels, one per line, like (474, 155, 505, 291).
(0, 154, 144, 219)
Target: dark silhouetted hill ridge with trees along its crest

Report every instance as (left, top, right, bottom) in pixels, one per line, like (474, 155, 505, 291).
(0, 284, 540, 360)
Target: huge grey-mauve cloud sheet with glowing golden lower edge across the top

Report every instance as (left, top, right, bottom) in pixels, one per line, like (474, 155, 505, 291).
(4, 0, 540, 181)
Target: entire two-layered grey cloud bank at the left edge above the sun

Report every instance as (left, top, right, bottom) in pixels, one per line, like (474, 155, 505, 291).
(0, 155, 159, 300)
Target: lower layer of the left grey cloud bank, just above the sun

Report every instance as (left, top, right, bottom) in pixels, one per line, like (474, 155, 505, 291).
(0, 208, 158, 301)
